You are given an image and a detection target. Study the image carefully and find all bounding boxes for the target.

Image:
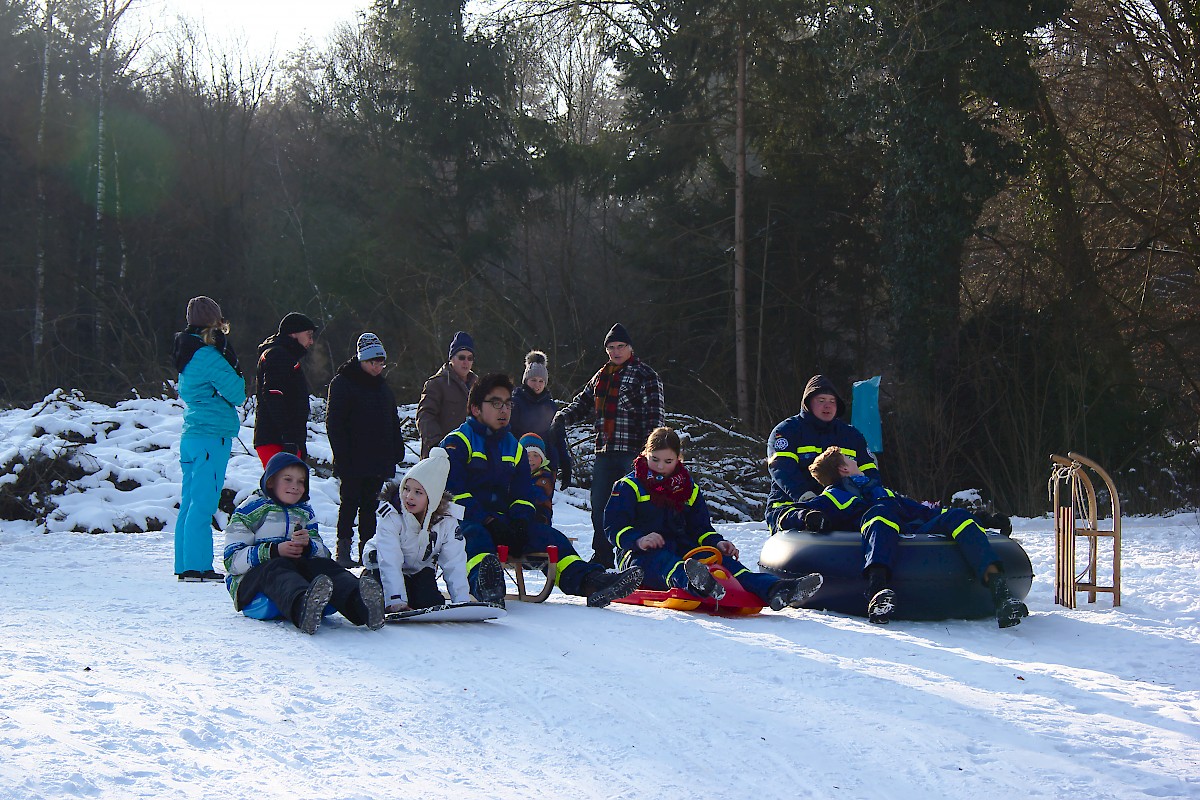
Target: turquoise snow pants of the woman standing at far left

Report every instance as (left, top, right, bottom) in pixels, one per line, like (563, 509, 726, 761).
(175, 435, 233, 575)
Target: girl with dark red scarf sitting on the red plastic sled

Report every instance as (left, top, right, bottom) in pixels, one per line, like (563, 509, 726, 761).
(604, 427, 821, 610)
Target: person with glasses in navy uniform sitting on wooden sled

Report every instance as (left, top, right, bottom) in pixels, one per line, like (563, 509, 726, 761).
(442, 374, 642, 608)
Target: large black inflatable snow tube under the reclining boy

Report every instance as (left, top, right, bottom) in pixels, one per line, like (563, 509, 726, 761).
(758, 530, 1033, 620)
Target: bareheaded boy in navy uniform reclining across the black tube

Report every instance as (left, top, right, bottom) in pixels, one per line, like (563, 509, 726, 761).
(803, 447, 1030, 627)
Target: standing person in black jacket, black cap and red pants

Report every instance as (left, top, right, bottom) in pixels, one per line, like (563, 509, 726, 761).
(254, 311, 317, 469)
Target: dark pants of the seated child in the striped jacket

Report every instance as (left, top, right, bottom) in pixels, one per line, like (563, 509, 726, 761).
(238, 555, 367, 625)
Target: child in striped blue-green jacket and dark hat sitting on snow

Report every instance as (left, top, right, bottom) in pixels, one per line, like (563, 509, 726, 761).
(224, 452, 383, 633)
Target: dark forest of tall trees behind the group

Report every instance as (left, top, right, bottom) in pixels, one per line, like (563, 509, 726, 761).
(0, 0, 1200, 515)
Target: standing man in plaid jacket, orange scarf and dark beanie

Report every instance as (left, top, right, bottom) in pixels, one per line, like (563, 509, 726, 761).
(552, 323, 666, 569)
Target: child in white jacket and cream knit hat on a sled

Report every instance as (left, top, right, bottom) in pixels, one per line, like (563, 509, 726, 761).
(362, 447, 475, 613)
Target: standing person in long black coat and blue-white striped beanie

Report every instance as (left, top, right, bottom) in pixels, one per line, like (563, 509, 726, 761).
(325, 333, 405, 567)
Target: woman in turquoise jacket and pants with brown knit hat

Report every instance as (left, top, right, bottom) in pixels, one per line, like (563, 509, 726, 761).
(173, 296, 246, 581)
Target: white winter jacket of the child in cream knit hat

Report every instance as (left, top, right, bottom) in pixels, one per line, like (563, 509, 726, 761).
(362, 500, 470, 606)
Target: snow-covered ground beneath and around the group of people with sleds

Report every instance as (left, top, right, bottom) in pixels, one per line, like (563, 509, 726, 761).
(0, 398, 1200, 800)
